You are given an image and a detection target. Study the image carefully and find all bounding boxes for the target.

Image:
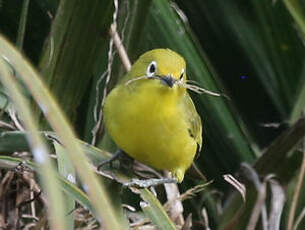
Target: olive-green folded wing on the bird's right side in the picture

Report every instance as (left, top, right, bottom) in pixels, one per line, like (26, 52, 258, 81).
(183, 94, 202, 152)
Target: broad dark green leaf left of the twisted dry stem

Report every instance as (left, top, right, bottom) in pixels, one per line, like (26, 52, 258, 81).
(37, 0, 113, 126)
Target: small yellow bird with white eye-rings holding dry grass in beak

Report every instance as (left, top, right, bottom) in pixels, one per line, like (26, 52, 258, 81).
(104, 49, 202, 183)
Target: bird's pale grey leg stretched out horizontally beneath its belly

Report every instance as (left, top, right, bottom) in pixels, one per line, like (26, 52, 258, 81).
(123, 178, 177, 188)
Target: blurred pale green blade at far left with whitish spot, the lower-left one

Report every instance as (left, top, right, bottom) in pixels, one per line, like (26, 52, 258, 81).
(0, 52, 65, 230)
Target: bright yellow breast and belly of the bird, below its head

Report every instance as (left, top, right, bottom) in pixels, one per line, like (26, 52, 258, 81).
(104, 80, 197, 181)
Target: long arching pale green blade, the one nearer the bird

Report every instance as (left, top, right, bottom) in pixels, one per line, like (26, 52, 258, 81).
(0, 37, 120, 230)
